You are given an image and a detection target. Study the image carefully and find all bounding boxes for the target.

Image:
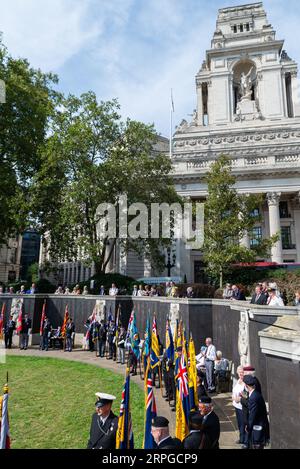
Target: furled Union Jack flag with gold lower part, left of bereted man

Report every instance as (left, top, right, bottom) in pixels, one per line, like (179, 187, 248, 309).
(175, 328, 190, 441)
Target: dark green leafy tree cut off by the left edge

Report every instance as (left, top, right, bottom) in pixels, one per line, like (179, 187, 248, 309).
(0, 36, 57, 244)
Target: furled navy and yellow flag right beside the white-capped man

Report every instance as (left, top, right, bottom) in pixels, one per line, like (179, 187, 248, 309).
(116, 368, 134, 449)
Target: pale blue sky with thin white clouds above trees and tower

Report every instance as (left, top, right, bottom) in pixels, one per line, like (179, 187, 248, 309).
(0, 0, 300, 136)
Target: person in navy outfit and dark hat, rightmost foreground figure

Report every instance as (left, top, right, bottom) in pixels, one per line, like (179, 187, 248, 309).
(244, 375, 268, 449)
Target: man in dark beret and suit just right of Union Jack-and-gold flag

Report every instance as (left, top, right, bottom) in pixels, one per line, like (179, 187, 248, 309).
(199, 396, 220, 449)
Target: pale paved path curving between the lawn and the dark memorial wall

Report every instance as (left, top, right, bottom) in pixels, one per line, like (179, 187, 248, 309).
(7, 348, 239, 449)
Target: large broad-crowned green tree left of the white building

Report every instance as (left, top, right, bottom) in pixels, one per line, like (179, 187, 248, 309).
(31, 92, 181, 273)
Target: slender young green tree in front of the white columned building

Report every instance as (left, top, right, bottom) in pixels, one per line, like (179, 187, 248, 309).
(203, 155, 278, 288)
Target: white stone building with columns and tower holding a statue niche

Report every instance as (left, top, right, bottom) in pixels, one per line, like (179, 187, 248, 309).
(172, 3, 300, 281)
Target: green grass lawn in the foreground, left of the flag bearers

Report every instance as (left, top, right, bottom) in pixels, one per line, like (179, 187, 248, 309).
(0, 356, 144, 449)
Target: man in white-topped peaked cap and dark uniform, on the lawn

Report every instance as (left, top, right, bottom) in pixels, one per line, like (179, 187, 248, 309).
(87, 392, 118, 449)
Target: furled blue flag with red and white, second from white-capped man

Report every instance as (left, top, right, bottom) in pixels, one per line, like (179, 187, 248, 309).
(144, 358, 157, 449)
